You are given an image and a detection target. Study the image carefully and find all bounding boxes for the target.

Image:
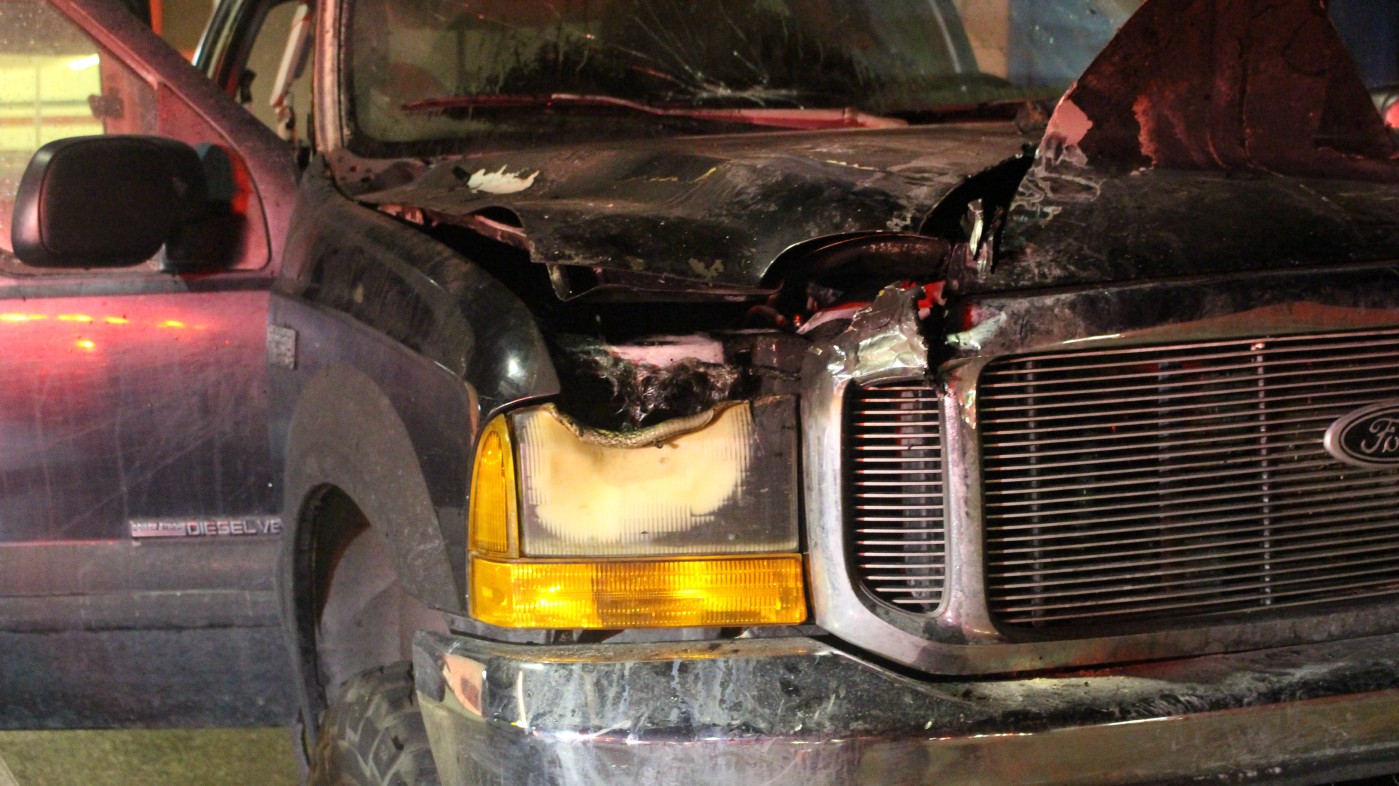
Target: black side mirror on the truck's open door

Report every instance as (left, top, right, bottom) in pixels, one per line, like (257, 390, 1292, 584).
(10, 136, 227, 267)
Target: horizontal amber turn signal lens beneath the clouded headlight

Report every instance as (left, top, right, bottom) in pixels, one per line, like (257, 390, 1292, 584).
(471, 554, 806, 628)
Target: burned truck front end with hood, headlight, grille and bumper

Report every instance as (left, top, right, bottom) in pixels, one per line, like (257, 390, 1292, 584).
(303, 0, 1399, 785)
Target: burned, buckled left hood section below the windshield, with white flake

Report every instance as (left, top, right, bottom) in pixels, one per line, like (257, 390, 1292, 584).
(358, 123, 1032, 291)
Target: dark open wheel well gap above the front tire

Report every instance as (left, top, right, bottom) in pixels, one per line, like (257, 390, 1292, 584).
(292, 487, 446, 704)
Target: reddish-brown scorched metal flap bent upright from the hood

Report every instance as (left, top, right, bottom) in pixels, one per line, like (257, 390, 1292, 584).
(1041, 0, 1399, 182)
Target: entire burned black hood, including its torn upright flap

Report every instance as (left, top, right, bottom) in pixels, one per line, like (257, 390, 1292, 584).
(358, 0, 1399, 292)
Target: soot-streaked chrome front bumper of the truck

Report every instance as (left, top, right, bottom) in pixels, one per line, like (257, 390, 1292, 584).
(414, 634, 1399, 786)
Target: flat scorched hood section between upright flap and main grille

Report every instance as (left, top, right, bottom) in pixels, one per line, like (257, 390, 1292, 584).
(973, 168, 1399, 292)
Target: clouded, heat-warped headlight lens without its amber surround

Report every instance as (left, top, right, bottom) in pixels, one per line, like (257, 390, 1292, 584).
(513, 403, 796, 557)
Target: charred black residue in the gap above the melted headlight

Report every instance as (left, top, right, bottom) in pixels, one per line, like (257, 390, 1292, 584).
(554, 331, 744, 431)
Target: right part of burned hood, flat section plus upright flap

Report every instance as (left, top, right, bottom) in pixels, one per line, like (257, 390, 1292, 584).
(961, 0, 1399, 291)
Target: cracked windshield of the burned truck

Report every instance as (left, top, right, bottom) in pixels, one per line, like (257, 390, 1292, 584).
(344, 0, 1140, 155)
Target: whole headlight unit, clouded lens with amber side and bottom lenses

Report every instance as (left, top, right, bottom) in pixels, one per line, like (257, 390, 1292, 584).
(470, 399, 806, 628)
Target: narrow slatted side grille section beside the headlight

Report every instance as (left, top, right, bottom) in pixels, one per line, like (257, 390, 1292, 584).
(845, 383, 947, 613)
